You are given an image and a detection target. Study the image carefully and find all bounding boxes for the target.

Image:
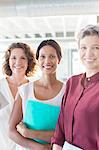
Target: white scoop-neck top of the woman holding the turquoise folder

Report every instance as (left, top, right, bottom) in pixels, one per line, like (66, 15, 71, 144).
(17, 82, 66, 150)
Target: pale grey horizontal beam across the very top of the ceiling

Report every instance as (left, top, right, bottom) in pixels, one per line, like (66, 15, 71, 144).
(0, 0, 99, 17)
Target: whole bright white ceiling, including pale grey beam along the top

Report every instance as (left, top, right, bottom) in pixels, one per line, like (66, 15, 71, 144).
(0, 0, 99, 40)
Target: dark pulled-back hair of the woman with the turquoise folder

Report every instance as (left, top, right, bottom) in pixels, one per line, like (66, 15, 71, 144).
(36, 39, 62, 61)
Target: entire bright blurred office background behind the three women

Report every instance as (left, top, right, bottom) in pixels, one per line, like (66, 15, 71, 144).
(0, 0, 99, 81)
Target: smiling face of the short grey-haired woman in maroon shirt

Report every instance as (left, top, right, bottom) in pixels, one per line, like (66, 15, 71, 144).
(79, 35, 99, 74)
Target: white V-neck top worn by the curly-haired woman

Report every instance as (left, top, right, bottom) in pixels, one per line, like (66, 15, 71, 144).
(0, 78, 16, 150)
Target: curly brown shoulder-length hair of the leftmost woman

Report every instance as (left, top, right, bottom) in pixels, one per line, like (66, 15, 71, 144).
(2, 42, 36, 76)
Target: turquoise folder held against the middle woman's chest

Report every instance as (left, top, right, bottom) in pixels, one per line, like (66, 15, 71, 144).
(23, 99, 60, 144)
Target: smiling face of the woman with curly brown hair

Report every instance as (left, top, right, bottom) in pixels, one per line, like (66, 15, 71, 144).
(9, 48, 28, 75)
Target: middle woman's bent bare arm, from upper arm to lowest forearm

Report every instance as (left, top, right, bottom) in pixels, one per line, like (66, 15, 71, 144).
(9, 96, 48, 150)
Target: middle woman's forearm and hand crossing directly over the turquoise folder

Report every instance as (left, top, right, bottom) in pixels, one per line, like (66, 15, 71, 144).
(17, 122, 54, 143)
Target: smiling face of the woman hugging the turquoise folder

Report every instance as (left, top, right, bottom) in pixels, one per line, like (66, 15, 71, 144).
(38, 45, 59, 74)
